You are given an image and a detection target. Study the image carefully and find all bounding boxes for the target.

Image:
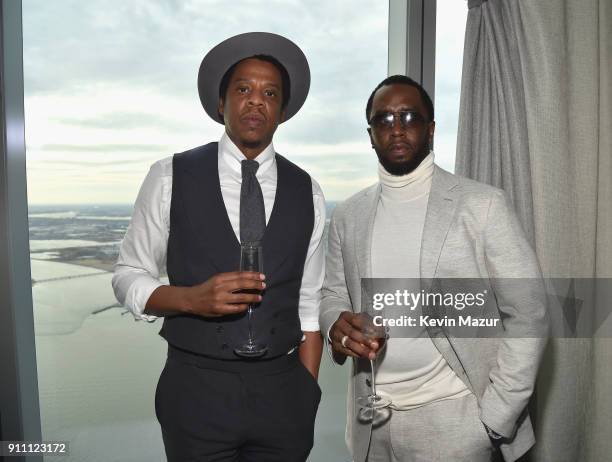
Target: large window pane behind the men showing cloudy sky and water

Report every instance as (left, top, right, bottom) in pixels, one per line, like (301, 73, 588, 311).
(23, 0, 388, 462)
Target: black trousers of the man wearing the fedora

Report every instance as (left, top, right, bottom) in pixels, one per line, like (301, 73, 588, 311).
(155, 347, 321, 462)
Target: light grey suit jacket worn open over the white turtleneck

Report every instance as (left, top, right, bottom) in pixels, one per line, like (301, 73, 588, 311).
(320, 166, 548, 462)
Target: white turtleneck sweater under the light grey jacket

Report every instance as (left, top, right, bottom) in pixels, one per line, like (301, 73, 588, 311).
(371, 151, 470, 410)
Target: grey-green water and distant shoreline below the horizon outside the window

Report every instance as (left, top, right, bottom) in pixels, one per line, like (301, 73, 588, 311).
(29, 204, 349, 462)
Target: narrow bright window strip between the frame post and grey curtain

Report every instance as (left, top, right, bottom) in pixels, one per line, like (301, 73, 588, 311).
(435, 0, 468, 172)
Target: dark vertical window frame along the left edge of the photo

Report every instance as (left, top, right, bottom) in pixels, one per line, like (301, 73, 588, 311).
(0, 0, 42, 462)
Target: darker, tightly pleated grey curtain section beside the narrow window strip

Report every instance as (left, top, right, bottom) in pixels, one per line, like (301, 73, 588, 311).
(455, 0, 534, 243)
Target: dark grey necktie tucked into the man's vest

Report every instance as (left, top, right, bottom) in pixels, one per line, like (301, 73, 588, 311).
(240, 160, 266, 245)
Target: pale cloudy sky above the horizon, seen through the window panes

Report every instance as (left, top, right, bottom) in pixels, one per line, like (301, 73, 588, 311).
(23, 0, 467, 204)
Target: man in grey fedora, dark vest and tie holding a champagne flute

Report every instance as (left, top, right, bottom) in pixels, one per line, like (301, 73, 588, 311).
(113, 32, 325, 462)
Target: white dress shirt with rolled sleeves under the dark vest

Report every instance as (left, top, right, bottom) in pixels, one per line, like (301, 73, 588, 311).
(113, 133, 325, 332)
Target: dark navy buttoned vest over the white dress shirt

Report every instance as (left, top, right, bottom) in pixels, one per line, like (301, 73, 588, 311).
(160, 143, 314, 359)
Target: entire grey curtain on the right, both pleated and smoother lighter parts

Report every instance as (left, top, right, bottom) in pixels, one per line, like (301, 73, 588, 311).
(457, 0, 612, 462)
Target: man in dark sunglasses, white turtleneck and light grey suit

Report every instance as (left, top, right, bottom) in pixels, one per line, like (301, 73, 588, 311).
(320, 75, 547, 462)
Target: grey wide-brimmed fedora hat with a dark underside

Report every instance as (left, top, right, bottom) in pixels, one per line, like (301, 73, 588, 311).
(198, 32, 310, 124)
